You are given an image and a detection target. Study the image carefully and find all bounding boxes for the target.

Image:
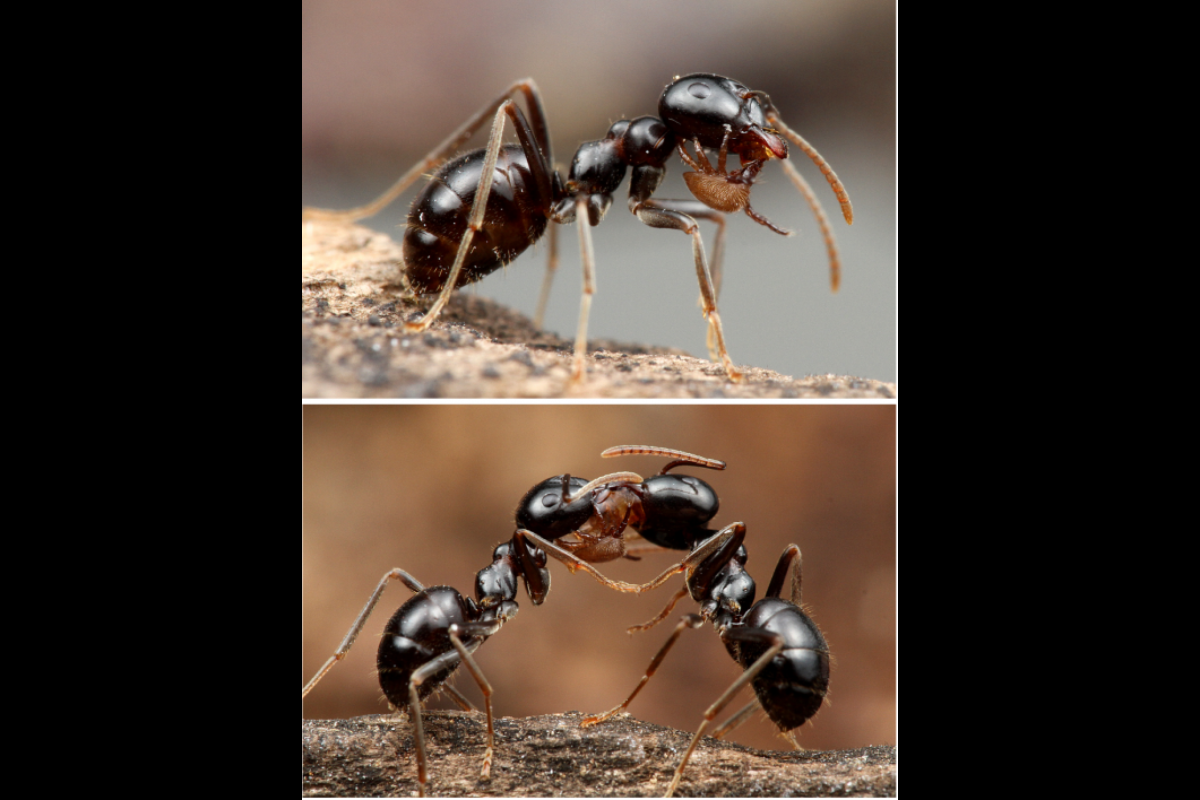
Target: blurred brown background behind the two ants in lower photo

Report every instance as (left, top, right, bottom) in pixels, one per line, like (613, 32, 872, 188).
(300, 405, 896, 750)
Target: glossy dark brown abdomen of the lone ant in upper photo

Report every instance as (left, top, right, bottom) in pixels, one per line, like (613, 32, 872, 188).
(404, 144, 550, 294)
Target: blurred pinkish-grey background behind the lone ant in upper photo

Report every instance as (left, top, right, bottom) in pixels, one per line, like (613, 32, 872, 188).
(301, 0, 896, 381)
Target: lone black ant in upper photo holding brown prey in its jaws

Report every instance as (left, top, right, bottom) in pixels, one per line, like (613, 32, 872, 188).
(304, 73, 853, 384)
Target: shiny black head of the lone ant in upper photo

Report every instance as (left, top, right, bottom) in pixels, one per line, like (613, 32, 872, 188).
(659, 72, 787, 163)
